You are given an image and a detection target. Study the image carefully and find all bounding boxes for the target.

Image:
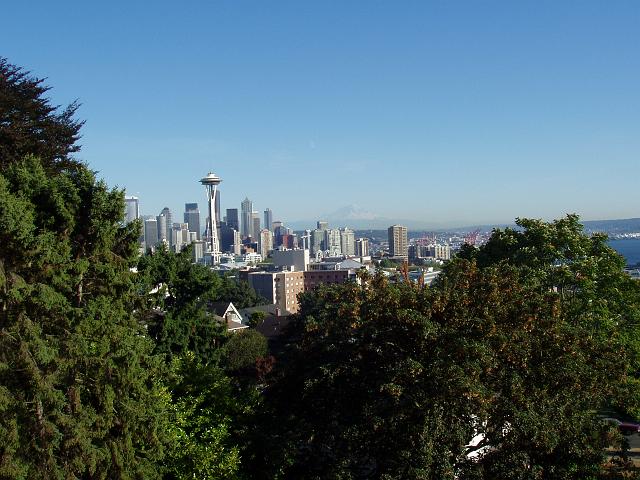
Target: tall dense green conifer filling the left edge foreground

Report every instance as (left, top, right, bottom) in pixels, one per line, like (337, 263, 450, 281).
(0, 157, 171, 479)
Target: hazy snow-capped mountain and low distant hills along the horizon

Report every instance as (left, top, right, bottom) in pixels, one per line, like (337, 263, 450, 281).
(287, 205, 640, 234)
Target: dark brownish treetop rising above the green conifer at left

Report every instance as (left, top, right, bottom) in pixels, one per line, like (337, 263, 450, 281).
(0, 57, 83, 173)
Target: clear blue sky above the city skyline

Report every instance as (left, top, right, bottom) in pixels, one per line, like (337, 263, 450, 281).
(0, 0, 640, 225)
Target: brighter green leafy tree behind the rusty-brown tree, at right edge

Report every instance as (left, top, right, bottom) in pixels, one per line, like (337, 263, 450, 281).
(458, 215, 640, 417)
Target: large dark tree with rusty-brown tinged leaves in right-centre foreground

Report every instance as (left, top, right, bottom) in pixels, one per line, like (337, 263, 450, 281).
(249, 218, 634, 479)
